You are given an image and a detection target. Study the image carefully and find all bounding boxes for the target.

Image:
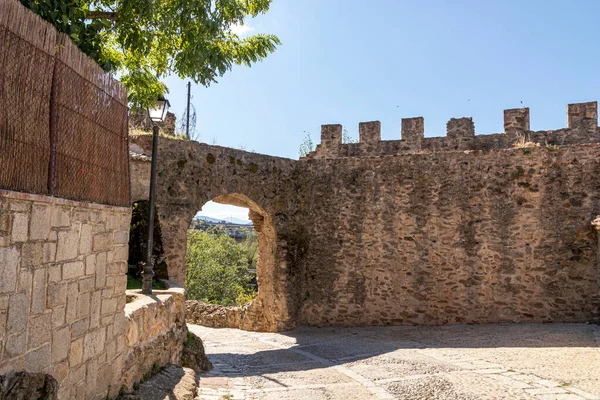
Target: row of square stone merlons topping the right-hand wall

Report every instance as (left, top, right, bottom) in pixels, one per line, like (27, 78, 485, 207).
(306, 101, 600, 158)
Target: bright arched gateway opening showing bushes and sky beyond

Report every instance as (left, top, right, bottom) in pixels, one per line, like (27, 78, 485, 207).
(186, 194, 264, 307)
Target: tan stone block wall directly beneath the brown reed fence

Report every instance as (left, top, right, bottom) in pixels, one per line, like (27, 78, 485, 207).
(0, 190, 131, 399)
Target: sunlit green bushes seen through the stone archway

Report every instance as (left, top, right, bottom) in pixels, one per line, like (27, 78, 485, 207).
(186, 229, 258, 306)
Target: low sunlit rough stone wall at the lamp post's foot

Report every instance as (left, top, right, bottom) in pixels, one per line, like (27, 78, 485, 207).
(123, 282, 187, 389)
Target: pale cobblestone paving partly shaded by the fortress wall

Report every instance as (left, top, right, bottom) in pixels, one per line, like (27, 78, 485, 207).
(188, 324, 600, 400)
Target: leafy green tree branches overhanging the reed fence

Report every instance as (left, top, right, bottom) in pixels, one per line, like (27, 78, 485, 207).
(21, 0, 280, 107)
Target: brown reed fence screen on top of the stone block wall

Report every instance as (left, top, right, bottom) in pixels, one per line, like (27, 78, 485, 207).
(0, 0, 130, 206)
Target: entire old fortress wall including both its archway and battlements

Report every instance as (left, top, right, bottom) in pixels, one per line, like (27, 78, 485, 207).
(132, 102, 600, 330)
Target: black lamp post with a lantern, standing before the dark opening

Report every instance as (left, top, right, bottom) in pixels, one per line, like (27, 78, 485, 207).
(142, 98, 171, 294)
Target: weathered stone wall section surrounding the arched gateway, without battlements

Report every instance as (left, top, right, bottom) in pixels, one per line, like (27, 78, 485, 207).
(131, 136, 299, 331)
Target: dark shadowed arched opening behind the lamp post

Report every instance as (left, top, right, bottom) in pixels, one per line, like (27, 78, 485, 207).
(127, 200, 169, 289)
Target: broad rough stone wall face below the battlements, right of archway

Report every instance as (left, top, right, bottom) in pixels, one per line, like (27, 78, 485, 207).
(298, 144, 600, 325)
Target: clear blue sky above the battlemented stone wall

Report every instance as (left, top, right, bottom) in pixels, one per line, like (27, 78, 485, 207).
(185, 0, 600, 222)
